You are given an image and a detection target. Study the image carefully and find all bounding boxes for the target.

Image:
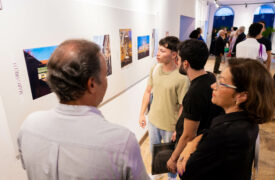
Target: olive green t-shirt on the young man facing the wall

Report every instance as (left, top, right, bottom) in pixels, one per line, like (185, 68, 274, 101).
(147, 64, 190, 131)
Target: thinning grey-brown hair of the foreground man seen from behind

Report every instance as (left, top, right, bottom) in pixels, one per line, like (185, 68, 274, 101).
(47, 39, 101, 102)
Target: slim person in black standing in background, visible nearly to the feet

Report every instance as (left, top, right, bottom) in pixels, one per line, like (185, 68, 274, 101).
(213, 30, 225, 74)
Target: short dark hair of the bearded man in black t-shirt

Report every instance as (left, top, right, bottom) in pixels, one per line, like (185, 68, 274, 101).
(178, 39, 209, 70)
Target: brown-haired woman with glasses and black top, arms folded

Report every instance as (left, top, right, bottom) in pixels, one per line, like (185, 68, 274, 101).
(177, 59, 275, 180)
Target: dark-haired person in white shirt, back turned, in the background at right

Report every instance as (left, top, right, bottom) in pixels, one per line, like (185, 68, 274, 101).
(236, 23, 267, 62)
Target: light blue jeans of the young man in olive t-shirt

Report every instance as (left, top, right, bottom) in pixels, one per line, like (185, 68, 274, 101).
(148, 121, 177, 178)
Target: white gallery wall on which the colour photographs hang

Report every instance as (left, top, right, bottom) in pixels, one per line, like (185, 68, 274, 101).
(0, 0, 198, 180)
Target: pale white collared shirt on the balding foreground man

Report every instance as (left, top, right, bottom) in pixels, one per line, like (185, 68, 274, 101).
(18, 104, 149, 180)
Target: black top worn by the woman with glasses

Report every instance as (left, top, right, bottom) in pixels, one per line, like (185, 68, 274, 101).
(181, 111, 259, 180)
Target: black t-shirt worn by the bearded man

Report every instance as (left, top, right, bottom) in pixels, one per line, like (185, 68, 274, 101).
(176, 72, 224, 141)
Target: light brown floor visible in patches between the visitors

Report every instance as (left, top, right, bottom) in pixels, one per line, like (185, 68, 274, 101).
(141, 57, 275, 180)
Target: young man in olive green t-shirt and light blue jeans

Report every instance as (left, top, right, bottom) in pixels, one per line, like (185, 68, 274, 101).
(139, 36, 189, 179)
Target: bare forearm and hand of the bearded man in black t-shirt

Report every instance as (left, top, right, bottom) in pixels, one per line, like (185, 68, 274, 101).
(167, 118, 200, 173)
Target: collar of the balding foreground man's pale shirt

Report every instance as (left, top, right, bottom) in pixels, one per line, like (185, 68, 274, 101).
(55, 103, 103, 117)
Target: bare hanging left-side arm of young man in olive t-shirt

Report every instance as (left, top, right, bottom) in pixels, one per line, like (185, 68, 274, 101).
(139, 85, 152, 128)
